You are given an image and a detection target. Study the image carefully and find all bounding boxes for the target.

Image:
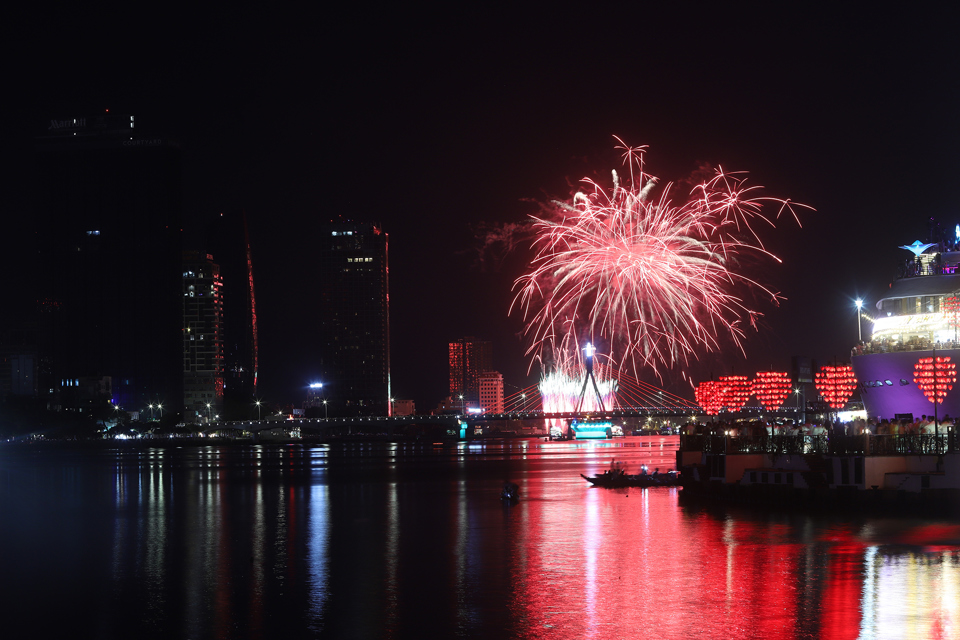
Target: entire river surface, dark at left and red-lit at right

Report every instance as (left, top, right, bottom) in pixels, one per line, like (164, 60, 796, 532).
(0, 437, 960, 640)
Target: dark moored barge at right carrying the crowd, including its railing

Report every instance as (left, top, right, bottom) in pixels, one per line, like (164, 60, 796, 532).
(677, 430, 960, 515)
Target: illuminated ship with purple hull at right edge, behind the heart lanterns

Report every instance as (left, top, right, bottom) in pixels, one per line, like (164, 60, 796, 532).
(851, 235, 960, 420)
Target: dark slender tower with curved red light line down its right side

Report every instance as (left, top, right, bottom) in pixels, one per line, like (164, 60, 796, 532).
(204, 212, 260, 420)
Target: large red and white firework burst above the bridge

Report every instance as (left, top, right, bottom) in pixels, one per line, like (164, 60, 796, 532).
(511, 138, 810, 390)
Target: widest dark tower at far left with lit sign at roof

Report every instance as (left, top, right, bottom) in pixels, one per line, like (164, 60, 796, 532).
(34, 113, 183, 410)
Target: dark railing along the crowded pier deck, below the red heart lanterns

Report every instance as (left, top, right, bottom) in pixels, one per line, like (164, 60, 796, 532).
(680, 431, 960, 456)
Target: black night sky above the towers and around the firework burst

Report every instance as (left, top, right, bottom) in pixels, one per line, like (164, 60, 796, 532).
(7, 3, 960, 410)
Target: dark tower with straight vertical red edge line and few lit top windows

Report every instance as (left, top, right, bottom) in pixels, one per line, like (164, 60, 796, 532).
(317, 223, 390, 416)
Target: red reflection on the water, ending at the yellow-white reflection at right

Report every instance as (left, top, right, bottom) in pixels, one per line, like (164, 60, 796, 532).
(506, 464, 865, 640)
